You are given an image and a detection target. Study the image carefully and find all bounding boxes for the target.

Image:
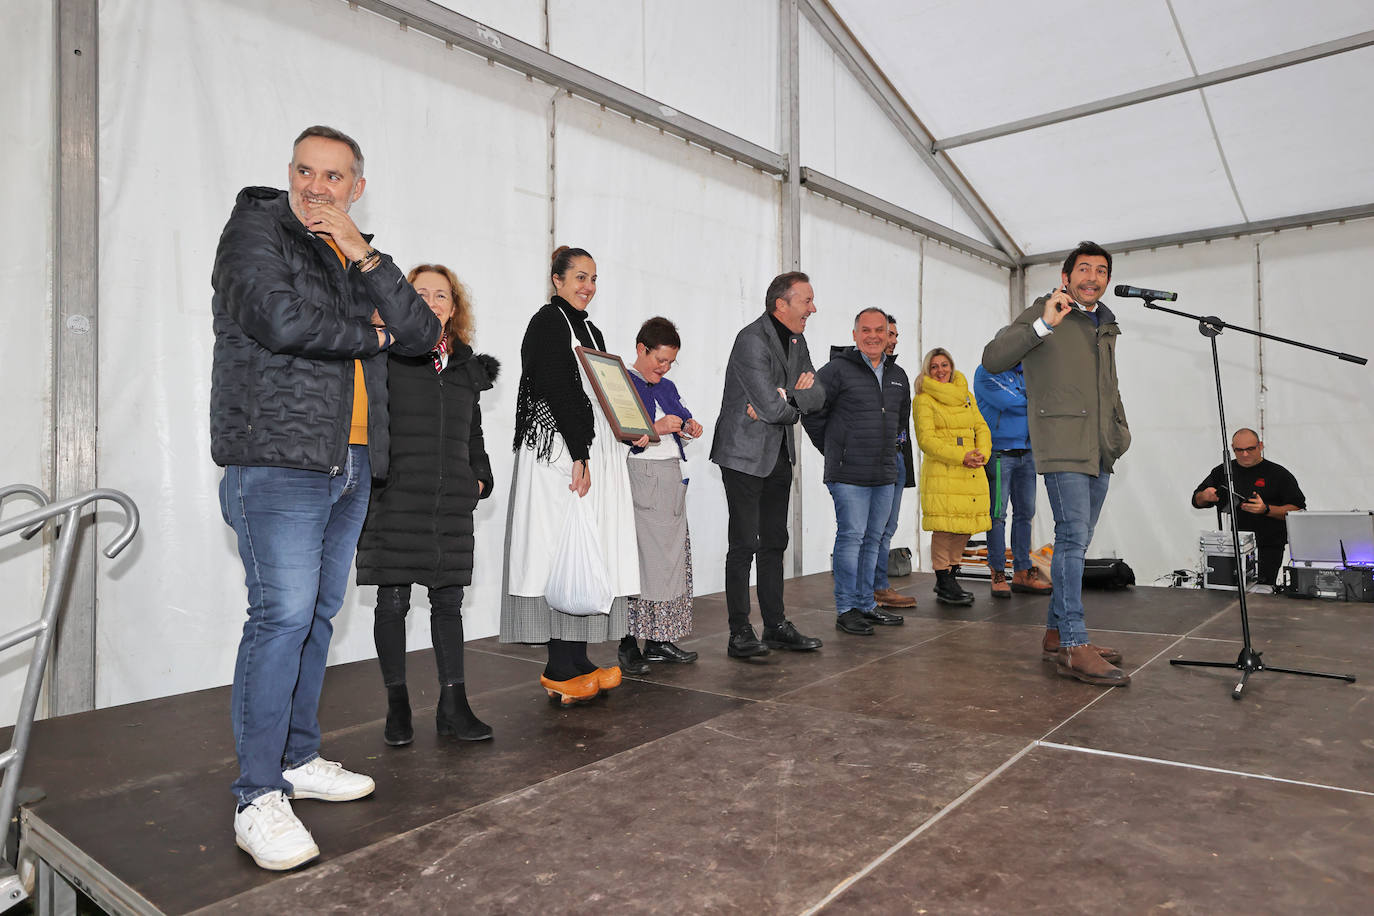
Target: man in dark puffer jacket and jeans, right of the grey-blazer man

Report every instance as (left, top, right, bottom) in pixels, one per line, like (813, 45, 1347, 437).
(801, 309, 911, 636)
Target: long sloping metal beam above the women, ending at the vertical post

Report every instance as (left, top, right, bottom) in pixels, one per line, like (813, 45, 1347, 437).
(350, 0, 787, 174)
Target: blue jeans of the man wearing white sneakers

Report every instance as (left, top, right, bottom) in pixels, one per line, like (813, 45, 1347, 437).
(220, 445, 372, 805)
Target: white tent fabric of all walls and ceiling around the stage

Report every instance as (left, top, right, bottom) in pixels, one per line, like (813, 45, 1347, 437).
(0, 0, 1374, 718)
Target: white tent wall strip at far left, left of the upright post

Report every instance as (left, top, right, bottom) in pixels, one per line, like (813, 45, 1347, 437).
(0, 0, 55, 724)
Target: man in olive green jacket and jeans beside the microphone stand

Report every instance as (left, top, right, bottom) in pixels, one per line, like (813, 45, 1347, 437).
(982, 242, 1131, 687)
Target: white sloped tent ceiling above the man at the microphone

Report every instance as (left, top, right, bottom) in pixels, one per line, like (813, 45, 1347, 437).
(830, 0, 1374, 255)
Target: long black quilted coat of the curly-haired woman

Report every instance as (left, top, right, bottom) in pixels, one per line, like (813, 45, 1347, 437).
(357, 343, 500, 588)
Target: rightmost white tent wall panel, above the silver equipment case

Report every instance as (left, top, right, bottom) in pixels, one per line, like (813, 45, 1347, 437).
(1259, 220, 1374, 511)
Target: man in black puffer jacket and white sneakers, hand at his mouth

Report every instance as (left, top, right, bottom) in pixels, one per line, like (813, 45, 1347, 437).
(210, 126, 440, 869)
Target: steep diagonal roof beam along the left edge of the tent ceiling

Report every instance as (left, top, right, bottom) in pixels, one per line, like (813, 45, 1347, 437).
(801, 0, 1021, 261)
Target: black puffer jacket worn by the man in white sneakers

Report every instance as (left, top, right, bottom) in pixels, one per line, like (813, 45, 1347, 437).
(210, 188, 440, 477)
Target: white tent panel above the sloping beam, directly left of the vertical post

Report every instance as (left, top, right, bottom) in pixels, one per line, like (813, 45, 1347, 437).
(548, 0, 780, 150)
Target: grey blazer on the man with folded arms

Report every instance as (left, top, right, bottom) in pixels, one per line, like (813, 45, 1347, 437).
(710, 313, 826, 477)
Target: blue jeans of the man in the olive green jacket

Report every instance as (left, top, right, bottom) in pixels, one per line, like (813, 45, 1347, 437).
(1044, 471, 1112, 647)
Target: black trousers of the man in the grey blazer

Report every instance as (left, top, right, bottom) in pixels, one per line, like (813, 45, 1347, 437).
(720, 439, 791, 633)
